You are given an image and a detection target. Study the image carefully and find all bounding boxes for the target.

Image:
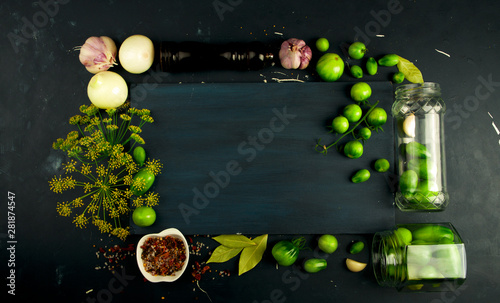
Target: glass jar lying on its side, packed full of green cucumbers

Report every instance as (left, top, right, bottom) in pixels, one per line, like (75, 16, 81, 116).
(371, 223, 467, 292)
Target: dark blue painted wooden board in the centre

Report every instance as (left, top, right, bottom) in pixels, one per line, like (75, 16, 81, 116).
(131, 82, 395, 235)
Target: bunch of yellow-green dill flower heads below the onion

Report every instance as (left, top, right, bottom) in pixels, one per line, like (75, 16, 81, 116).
(48, 102, 162, 240)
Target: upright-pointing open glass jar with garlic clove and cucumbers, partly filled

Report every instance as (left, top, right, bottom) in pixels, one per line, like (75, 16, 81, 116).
(392, 83, 449, 211)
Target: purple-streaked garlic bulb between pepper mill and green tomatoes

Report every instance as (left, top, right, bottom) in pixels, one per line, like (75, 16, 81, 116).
(279, 38, 312, 69)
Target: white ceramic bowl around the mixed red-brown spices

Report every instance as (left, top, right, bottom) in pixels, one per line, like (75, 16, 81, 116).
(136, 228, 189, 283)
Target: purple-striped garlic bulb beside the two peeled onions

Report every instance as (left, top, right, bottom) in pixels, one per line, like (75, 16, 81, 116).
(79, 36, 117, 74)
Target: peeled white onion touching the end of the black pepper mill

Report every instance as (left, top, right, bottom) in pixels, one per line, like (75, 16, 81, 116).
(118, 35, 154, 74)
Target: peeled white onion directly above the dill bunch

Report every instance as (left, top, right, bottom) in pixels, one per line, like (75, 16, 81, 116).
(87, 71, 128, 109)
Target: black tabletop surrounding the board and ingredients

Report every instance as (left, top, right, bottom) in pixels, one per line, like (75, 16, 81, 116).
(0, 0, 500, 303)
